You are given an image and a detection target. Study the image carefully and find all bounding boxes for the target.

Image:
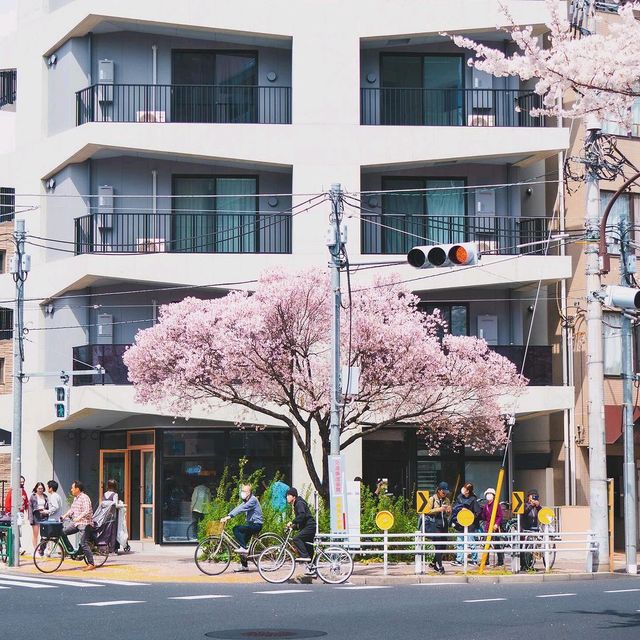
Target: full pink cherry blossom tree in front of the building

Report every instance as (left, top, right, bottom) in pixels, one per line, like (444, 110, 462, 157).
(124, 271, 526, 497)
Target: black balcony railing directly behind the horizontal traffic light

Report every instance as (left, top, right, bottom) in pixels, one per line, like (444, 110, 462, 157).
(361, 214, 551, 255)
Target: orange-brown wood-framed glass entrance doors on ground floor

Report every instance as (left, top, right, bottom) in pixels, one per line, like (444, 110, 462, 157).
(100, 431, 155, 540)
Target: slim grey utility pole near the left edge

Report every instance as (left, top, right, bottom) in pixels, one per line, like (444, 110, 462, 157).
(10, 220, 30, 567)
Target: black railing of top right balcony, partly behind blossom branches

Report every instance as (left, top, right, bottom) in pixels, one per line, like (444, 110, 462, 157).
(360, 87, 544, 127)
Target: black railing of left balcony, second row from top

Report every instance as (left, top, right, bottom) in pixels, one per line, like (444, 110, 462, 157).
(75, 211, 291, 254)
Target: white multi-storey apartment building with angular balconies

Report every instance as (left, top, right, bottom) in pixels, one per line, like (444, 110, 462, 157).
(0, 0, 573, 543)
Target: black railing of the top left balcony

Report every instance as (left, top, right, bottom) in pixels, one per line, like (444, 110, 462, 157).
(76, 84, 291, 125)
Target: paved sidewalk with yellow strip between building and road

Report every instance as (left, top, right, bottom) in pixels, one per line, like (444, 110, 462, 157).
(2, 547, 632, 585)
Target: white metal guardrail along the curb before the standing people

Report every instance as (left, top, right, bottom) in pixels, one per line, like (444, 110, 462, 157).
(316, 528, 598, 575)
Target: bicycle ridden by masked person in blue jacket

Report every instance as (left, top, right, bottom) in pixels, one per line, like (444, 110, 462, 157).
(193, 520, 282, 576)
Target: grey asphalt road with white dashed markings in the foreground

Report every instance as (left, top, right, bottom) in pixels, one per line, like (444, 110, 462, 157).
(0, 572, 640, 640)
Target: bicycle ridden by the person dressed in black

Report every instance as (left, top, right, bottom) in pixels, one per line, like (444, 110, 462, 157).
(258, 528, 353, 584)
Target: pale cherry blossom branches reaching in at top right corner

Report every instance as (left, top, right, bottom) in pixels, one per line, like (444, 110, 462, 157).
(452, 0, 640, 127)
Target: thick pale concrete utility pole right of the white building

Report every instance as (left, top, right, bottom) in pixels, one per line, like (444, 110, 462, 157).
(585, 117, 612, 571)
